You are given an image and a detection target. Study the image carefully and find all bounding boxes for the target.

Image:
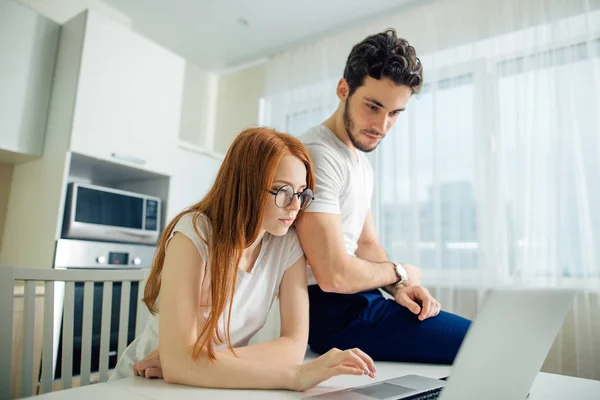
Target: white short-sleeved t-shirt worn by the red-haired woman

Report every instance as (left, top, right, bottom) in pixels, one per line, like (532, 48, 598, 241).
(110, 213, 303, 380)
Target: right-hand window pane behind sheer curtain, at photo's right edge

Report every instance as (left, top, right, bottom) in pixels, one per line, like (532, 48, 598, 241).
(497, 40, 600, 277)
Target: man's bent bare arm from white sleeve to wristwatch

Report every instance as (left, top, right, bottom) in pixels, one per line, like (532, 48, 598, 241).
(296, 212, 398, 293)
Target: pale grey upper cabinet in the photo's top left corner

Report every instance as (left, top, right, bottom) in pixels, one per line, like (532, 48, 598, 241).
(0, 1, 60, 163)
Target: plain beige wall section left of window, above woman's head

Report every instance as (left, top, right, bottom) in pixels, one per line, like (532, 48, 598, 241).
(214, 63, 265, 153)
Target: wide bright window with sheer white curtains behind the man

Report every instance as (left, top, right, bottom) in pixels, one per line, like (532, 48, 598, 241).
(263, 19, 600, 279)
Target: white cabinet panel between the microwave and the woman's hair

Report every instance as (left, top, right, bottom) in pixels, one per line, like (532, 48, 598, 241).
(165, 148, 222, 225)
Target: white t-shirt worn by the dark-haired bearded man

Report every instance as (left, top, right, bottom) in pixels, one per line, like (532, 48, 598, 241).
(300, 125, 373, 285)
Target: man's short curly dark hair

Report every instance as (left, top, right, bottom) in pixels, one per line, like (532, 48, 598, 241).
(344, 28, 423, 96)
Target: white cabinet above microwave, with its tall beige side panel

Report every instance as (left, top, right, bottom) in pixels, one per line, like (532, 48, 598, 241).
(0, 8, 185, 268)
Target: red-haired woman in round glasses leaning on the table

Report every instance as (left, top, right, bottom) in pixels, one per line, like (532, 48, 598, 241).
(111, 128, 375, 390)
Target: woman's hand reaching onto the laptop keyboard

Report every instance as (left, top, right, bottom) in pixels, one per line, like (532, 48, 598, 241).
(290, 348, 376, 391)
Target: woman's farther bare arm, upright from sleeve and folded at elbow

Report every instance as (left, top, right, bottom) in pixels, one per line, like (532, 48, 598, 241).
(226, 256, 308, 365)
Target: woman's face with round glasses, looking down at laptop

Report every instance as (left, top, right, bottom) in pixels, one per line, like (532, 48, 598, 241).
(262, 155, 306, 236)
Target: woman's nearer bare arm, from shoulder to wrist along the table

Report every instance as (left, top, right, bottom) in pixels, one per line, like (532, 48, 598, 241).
(158, 234, 291, 388)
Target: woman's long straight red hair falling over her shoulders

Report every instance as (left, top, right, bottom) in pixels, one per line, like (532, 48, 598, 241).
(143, 128, 315, 360)
